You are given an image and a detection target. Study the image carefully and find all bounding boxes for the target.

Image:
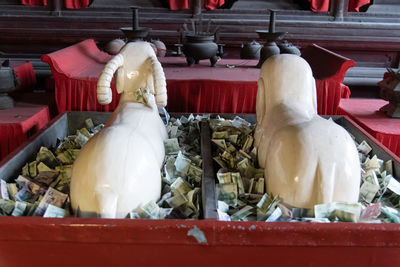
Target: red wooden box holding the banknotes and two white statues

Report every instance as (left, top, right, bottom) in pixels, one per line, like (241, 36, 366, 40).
(0, 112, 400, 267)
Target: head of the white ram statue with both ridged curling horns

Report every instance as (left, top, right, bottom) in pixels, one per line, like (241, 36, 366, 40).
(97, 42, 167, 107)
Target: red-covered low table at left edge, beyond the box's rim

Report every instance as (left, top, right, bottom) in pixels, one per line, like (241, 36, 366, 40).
(0, 103, 50, 160)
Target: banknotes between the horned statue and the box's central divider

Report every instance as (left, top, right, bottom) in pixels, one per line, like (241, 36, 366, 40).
(130, 115, 208, 219)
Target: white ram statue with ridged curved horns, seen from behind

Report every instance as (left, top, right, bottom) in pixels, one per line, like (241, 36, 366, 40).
(71, 42, 168, 218)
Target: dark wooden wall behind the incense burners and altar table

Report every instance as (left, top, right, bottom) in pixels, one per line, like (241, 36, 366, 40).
(0, 0, 400, 96)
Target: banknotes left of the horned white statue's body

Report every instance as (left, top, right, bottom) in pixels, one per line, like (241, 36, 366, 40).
(0, 119, 103, 217)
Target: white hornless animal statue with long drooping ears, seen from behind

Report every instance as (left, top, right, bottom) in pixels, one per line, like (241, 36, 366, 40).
(255, 54, 361, 208)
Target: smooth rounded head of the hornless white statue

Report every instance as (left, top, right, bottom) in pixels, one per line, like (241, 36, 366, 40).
(254, 54, 317, 152)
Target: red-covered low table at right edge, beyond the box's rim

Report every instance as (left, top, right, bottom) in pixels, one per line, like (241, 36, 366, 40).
(338, 99, 400, 157)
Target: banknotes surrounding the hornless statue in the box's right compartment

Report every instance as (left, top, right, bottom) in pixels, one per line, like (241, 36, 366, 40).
(214, 117, 400, 223)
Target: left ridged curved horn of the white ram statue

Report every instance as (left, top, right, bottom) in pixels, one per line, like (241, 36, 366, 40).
(97, 54, 124, 105)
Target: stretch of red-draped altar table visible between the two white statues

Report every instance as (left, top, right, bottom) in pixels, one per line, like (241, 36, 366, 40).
(160, 57, 260, 113)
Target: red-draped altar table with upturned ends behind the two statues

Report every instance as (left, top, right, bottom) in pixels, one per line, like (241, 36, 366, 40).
(42, 39, 350, 115)
